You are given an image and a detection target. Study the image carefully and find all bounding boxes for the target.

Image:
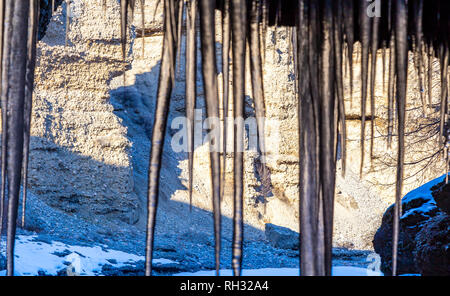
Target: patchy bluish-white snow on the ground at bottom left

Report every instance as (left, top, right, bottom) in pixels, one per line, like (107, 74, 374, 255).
(0, 235, 177, 276)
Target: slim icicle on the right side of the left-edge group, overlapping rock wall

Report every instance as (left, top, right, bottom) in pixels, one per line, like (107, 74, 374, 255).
(22, 0, 39, 228)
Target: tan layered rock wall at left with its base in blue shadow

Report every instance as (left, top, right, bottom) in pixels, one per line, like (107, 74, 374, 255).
(1, 0, 138, 223)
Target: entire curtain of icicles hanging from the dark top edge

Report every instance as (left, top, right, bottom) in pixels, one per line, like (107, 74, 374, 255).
(0, 0, 450, 275)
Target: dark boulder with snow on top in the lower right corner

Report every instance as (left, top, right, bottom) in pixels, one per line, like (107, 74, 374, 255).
(373, 178, 450, 275)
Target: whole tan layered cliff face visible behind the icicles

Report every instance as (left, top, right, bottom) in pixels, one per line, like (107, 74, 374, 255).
(3, 0, 443, 249)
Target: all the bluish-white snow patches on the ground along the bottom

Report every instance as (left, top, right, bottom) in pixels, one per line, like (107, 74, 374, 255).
(0, 235, 383, 276)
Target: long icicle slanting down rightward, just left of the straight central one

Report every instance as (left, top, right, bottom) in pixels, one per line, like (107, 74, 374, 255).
(199, 0, 221, 275)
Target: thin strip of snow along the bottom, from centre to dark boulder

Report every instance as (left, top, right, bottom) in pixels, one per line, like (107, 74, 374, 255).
(174, 266, 383, 276)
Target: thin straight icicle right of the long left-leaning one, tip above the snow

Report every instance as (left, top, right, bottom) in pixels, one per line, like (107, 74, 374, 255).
(186, 0, 197, 210)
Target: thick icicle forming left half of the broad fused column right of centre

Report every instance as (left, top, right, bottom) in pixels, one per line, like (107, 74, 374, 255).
(297, 0, 324, 276)
